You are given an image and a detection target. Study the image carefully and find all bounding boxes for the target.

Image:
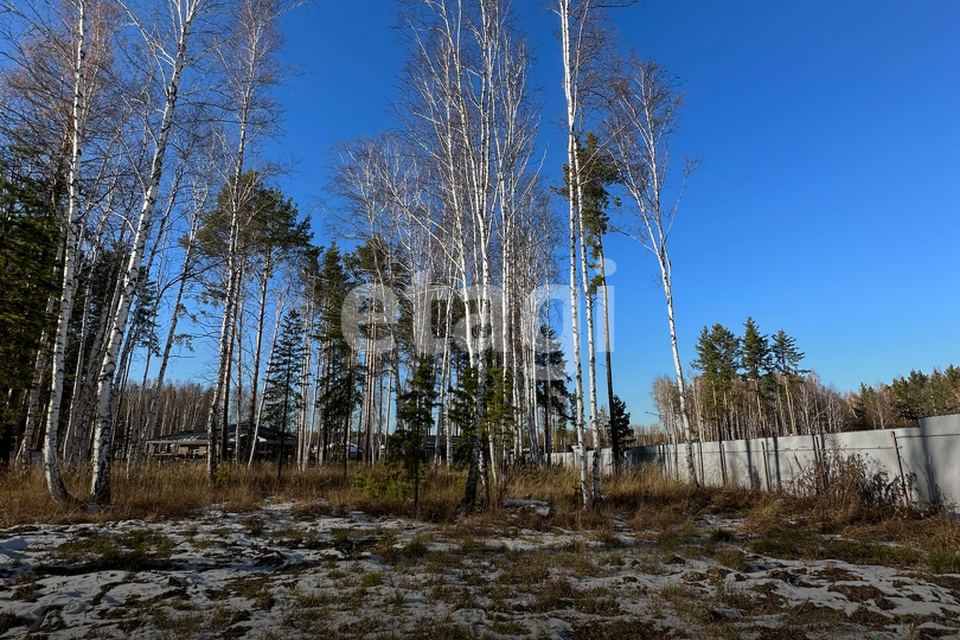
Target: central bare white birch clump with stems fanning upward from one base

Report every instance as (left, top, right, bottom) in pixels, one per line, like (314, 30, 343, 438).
(401, 0, 540, 509)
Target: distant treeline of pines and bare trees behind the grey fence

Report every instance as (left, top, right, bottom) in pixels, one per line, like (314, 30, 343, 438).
(652, 318, 960, 442)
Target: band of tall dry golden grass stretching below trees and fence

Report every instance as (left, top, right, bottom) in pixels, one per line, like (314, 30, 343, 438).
(0, 463, 960, 573)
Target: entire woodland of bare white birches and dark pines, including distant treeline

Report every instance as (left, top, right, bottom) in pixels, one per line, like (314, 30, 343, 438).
(0, 0, 954, 509)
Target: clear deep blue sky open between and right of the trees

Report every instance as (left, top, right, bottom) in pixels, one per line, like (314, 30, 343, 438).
(266, 0, 960, 424)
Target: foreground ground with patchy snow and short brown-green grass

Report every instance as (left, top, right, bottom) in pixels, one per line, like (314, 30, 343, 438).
(0, 502, 960, 640)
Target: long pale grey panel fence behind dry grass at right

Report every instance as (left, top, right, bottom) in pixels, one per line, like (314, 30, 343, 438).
(554, 415, 960, 508)
